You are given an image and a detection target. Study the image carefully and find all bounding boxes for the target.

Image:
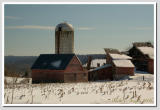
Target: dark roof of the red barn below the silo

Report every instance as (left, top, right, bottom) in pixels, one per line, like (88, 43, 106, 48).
(31, 54, 75, 70)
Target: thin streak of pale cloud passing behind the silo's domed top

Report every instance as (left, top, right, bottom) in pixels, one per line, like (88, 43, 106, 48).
(5, 25, 95, 31)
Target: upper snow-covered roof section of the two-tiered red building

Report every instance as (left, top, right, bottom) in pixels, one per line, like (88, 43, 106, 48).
(109, 53, 132, 60)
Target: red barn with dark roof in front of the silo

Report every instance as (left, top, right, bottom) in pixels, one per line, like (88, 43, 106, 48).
(31, 54, 88, 83)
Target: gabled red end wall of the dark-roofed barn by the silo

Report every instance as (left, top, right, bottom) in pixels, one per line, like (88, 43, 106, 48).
(64, 56, 88, 82)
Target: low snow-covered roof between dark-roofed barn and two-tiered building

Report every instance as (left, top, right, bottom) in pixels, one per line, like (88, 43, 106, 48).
(83, 59, 106, 67)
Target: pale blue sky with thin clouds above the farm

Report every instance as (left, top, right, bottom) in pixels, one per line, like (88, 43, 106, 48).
(4, 4, 154, 56)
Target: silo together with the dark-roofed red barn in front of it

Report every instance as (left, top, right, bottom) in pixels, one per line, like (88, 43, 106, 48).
(31, 22, 88, 83)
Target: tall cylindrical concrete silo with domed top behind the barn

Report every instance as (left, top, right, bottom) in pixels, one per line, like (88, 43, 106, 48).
(55, 22, 74, 54)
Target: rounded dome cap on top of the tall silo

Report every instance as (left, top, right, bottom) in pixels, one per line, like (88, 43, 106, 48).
(55, 22, 74, 31)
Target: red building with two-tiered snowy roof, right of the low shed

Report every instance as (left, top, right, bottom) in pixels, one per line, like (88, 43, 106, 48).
(105, 49, 134, 79)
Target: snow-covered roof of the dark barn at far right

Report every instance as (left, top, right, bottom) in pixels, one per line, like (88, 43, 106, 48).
(137, 47, 154, 59)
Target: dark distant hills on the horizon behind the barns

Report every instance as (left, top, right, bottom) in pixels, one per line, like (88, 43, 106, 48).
(4, 54, 106, 75)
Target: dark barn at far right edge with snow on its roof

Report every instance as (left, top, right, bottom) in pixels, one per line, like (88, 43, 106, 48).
(128, 42, 154, 74)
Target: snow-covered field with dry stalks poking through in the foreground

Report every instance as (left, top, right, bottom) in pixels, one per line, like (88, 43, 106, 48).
(4, 73, 154, 104)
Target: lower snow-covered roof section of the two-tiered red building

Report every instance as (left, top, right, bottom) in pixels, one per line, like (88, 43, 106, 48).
(113, 60, 134, 67)
